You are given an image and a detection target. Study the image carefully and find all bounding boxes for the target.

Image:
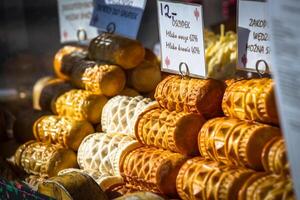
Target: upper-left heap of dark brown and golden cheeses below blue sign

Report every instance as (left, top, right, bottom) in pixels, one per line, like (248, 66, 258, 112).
(29, 33, 161, 130)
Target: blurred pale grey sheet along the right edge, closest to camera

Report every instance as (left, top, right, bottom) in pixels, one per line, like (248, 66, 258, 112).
(270, 0, 300, 199)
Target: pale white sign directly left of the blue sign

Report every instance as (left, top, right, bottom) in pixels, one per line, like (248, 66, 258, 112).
(58, 0, 98, 43)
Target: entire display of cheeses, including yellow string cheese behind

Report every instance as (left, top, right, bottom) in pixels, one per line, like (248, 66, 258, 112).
(10, 30, 294, 200)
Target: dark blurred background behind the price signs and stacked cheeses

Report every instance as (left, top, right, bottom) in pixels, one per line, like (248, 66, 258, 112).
(0, 0, 236, 112)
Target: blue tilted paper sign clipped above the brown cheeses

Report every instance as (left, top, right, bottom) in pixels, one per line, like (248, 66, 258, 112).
(90, 0, 146, 39)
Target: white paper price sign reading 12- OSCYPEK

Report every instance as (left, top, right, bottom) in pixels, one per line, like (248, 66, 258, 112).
(157, 0, 207, 77)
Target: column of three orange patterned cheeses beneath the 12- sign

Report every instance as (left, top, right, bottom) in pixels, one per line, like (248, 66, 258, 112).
(113, 76, 225, 197)
